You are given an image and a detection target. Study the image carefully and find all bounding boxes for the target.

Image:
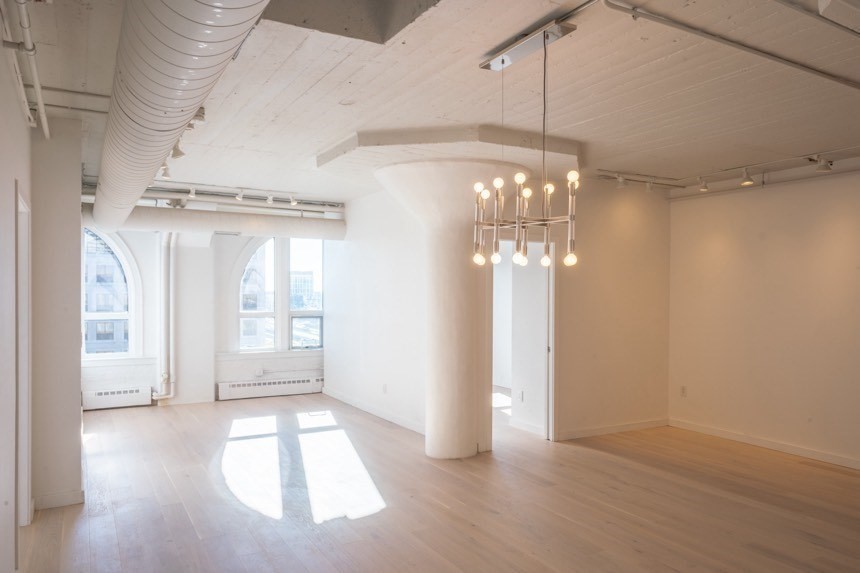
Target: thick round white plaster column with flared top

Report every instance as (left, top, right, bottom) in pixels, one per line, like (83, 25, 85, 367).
(376, 160, 526, 458)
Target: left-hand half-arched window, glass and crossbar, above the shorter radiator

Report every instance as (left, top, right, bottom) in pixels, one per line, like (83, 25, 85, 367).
(81, 229, 129, 355)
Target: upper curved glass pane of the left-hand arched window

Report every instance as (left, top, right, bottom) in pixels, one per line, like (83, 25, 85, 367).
(83, 229, 128, 312)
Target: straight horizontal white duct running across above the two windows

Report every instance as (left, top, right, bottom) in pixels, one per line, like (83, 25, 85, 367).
(81, 203, 346, 241)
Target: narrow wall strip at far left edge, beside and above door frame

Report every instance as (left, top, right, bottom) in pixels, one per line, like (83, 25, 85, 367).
(0, 47, 30, 571)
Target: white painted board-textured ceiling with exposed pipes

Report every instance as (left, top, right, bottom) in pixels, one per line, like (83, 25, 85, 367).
(11, 0, 860, 201)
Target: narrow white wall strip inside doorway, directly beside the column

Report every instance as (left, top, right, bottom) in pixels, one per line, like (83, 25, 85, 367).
(492, 241, 514, 389)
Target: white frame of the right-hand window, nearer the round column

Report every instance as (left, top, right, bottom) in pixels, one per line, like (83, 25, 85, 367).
(231, 237, 325, 354)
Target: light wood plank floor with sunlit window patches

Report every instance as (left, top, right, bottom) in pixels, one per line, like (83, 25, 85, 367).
(21, 395, 860, 573)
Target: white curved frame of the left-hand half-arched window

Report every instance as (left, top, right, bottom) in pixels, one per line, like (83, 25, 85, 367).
(80, 226, 142, 362)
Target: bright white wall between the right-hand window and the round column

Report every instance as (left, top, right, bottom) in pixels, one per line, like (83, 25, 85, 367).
(324, 192, 426, 432)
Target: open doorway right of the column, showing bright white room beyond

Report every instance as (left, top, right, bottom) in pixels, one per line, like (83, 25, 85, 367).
(493, 241, 553, 439)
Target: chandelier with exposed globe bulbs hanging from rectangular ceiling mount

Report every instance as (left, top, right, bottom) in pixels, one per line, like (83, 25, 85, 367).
(472, 20, 579, 267)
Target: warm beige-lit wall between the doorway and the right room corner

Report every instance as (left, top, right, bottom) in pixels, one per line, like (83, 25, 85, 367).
(554, 180, 669, 439)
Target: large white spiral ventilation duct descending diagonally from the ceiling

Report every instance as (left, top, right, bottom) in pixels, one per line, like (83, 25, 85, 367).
(93, 0, 268, 230)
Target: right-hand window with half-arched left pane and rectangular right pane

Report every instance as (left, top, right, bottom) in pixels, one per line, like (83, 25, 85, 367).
(239, 239, 323, 350)
